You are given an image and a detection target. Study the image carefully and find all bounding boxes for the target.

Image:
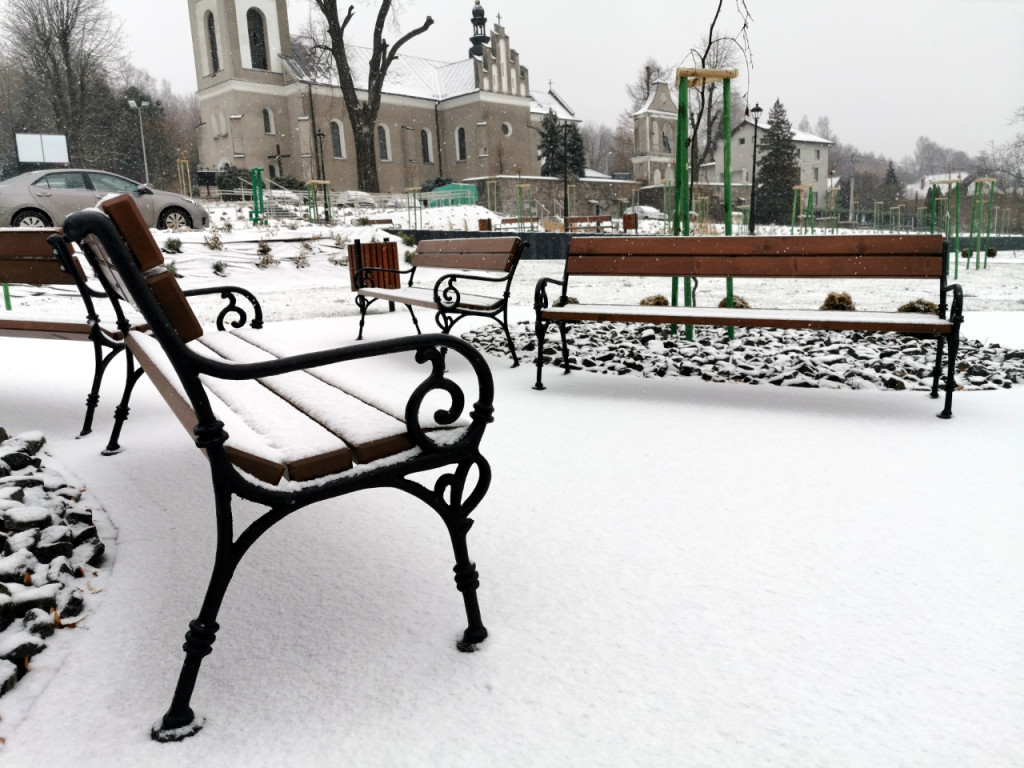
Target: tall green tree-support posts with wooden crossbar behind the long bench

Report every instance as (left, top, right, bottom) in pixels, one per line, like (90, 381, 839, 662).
(672, 68, 739, 340)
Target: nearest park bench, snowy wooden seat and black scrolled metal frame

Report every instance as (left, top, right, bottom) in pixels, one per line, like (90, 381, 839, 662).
(57, 196, 494, 741)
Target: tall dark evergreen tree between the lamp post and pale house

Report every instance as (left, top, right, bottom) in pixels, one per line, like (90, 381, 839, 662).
(754, 99, 800, 224)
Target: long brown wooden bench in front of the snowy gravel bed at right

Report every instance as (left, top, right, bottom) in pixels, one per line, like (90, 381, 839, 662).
(534, 234, 964, 419)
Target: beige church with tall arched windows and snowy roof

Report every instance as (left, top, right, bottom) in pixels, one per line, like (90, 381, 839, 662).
(188, 0, 578, 193)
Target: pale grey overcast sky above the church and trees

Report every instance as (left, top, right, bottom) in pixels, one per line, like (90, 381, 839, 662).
(106, 0, 1024, 161)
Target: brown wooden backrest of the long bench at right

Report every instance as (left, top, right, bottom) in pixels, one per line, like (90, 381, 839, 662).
(565, 234, 946, 279)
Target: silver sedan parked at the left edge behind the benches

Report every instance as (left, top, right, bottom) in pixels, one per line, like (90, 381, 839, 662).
(0, 168, 210, 229)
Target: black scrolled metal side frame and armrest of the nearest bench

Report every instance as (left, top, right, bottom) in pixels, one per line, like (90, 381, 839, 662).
(63, 198, 494, 741)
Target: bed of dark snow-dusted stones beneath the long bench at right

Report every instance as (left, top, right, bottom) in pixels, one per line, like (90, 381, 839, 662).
(464, 322, 1024, 390)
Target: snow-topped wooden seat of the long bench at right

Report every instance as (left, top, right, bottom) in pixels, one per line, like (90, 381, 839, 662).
(541, 304, 952, 334)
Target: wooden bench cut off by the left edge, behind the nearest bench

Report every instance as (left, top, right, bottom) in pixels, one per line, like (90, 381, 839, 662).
(0, 227, 127, 447)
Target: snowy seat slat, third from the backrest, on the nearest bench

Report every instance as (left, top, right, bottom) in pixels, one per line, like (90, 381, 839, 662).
(200, 332, 413, 464)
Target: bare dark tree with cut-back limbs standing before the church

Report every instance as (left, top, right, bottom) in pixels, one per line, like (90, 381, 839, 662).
(307, 0, 434, 191)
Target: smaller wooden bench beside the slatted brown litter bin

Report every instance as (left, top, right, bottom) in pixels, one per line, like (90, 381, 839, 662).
(355, 237, 526, 368)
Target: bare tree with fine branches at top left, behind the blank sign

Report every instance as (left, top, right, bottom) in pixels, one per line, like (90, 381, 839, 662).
(0, 0, 122, 162)
